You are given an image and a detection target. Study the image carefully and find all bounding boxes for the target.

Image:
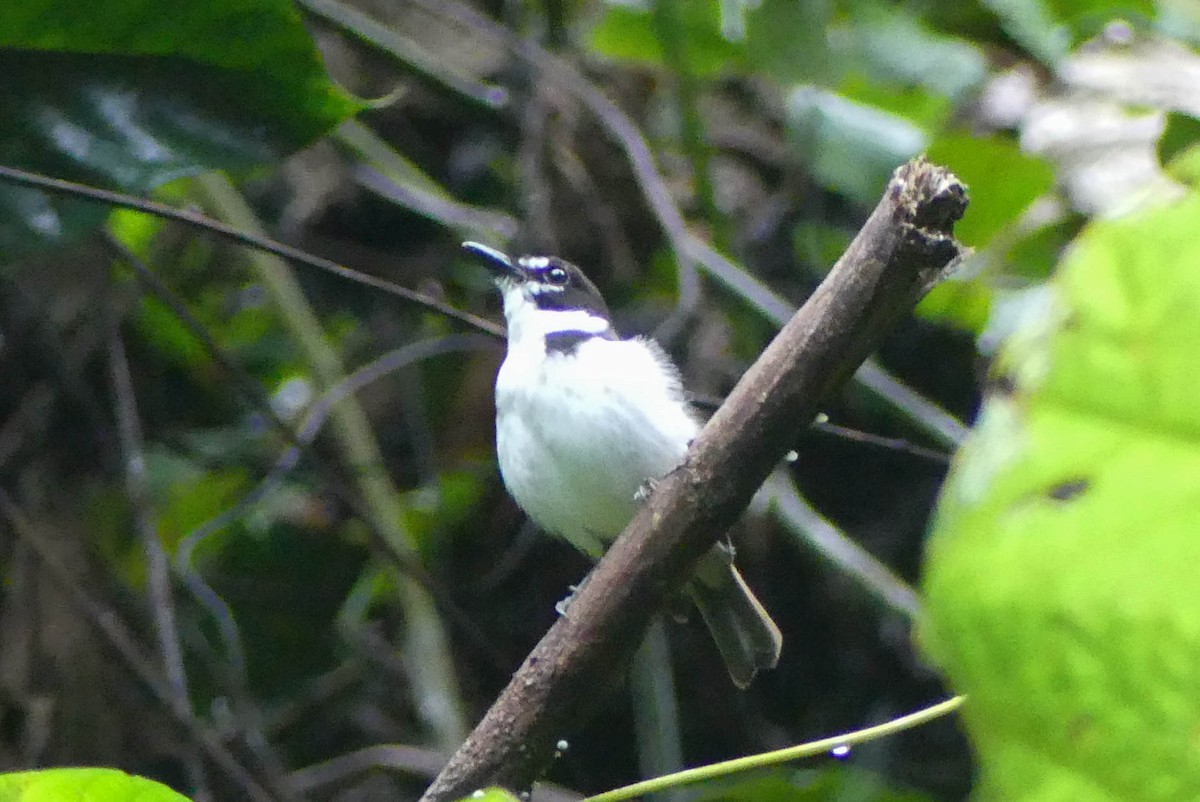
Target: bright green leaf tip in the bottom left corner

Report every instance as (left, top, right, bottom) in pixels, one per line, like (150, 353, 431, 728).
(0, 768, 187, 802)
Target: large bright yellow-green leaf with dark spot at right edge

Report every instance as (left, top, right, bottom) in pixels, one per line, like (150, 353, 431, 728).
(920, 190, 1200, 802)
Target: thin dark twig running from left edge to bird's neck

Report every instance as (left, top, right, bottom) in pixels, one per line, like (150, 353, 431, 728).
(0, 164, 504, 337)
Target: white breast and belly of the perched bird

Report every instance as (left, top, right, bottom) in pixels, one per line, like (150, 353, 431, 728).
(496, 341, 698, 557)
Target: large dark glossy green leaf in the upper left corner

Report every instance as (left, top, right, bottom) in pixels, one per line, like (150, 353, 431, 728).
(0, 0, 360, 256)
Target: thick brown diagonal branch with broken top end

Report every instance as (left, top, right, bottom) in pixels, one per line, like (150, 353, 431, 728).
(422, 158, 966, 802)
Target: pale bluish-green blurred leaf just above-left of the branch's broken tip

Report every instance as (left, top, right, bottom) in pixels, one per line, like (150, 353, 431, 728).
(787, 86, 926, 204)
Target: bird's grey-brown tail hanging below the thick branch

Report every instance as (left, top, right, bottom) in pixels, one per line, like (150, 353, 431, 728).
(688, 543, 784, 688)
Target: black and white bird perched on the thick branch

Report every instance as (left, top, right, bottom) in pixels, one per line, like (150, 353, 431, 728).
(463, 243, 782, 688)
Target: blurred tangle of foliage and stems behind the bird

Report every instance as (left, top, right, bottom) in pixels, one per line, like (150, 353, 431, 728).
(0, 0, 1200, 802)
